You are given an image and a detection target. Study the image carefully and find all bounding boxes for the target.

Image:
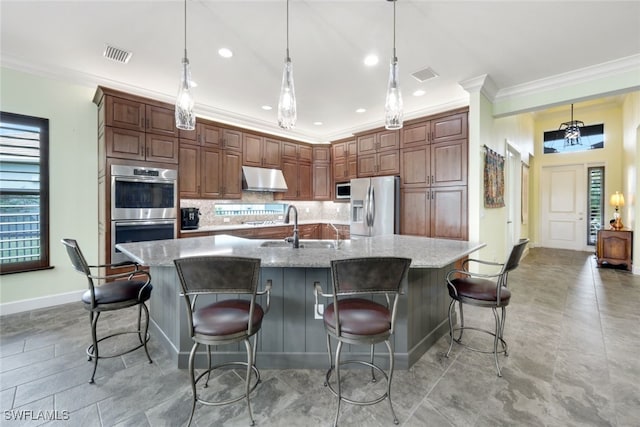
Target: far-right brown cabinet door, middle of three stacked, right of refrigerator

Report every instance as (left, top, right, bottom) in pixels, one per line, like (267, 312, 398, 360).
(430, 139, 467, 187)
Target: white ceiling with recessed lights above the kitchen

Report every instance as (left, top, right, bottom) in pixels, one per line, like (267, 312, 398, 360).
(0, 0, 640, 142)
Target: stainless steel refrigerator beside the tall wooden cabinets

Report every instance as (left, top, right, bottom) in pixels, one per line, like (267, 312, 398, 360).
(350, 176, 400, 239)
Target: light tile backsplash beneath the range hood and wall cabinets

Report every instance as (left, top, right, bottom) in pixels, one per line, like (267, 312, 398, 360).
(180, 191, 350, 227)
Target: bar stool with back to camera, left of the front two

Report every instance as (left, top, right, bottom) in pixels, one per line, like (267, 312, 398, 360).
(174, 256, 271, 425)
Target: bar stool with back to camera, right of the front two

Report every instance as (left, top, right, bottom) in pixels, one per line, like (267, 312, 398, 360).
(314, 257, 411, 426)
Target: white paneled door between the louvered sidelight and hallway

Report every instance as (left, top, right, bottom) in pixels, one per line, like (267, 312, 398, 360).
(540, 165, 586, 250)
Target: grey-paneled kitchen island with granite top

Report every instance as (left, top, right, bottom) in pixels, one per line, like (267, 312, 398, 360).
(117, 235, 484, 369)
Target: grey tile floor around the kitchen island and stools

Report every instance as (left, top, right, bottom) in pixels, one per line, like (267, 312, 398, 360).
(0, 248, 640, 427)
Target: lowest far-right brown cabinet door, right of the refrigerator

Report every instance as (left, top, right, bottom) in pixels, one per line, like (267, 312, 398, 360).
(430, 186, 467, 240)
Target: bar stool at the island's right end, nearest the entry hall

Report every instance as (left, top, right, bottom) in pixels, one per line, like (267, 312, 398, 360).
(446, 239, 529, 377)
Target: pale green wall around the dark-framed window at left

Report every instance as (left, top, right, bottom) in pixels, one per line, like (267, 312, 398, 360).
(0, 68, 98, 314)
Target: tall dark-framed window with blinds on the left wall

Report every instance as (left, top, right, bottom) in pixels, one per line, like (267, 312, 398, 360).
(0, 112, 49, 274)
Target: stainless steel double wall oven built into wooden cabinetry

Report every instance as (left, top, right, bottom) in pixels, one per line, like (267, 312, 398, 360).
(111, 165, 178, 263)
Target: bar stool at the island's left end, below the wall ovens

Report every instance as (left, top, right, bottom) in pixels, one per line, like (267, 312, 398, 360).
(62, 239, 153, 384)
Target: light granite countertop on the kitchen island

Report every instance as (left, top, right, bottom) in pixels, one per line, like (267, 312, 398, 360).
(116, 235, 485, 268)
